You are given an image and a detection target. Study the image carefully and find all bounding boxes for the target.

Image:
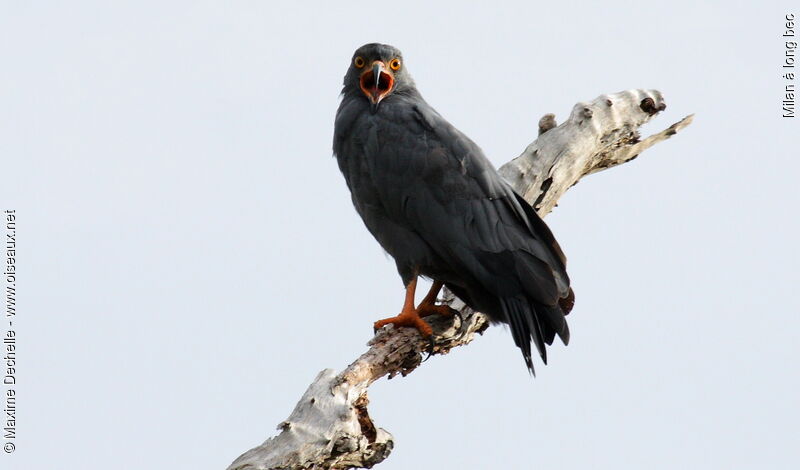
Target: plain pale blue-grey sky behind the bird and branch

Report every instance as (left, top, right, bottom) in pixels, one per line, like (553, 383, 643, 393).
(0, 1, 800, 470)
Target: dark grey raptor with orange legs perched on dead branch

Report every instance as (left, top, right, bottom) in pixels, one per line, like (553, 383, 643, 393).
(333, 43, 575, 375)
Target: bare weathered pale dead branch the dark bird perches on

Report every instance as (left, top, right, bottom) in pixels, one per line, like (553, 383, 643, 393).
(228, 90, 693, 470)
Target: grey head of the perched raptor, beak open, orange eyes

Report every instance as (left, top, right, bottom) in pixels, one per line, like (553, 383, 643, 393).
(343, 43, 414, 111)
